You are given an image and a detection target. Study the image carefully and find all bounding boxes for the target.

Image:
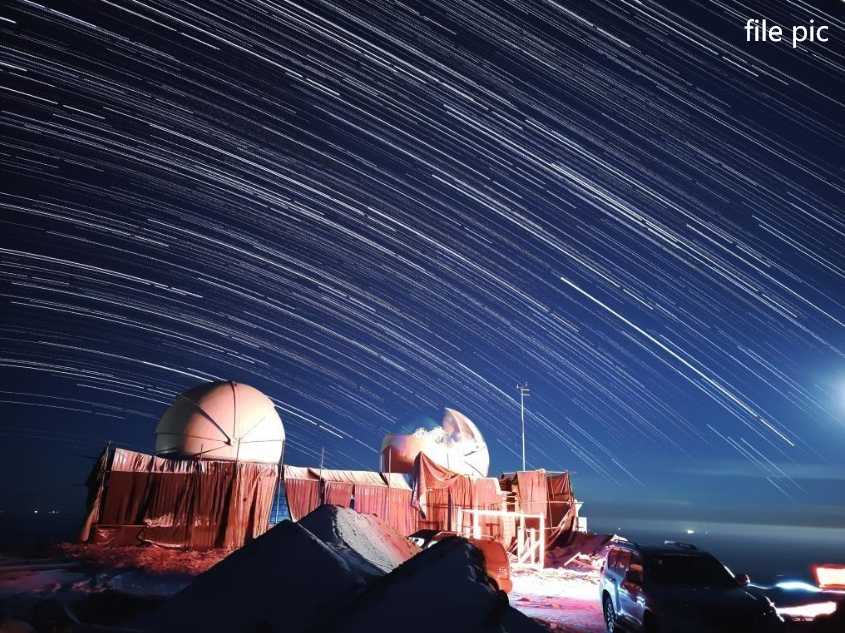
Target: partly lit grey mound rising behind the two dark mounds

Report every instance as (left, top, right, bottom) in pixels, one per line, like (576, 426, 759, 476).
(299, 505, 420, 577)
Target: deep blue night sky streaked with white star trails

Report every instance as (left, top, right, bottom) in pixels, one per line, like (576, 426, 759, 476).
(0, 0, 845, 527)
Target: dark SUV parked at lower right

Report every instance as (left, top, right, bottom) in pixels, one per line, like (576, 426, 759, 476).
(599, 541, 783, 633)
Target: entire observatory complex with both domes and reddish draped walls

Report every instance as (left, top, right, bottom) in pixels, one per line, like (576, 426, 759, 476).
(80, 390, 581, 564)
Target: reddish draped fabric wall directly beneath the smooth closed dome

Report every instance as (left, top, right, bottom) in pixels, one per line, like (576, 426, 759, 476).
(83, 449, 278, 549)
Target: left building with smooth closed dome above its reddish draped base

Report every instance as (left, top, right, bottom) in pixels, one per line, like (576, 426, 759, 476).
(80, 382, 285, 550)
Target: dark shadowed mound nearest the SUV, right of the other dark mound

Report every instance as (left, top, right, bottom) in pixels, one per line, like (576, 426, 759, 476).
(309, 538, 543, 633)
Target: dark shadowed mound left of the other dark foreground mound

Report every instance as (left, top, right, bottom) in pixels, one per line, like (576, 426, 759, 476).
(126, 521, 366, 633)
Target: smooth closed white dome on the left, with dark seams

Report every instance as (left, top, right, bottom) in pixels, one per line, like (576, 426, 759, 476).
(156, 382, 285, 464)
